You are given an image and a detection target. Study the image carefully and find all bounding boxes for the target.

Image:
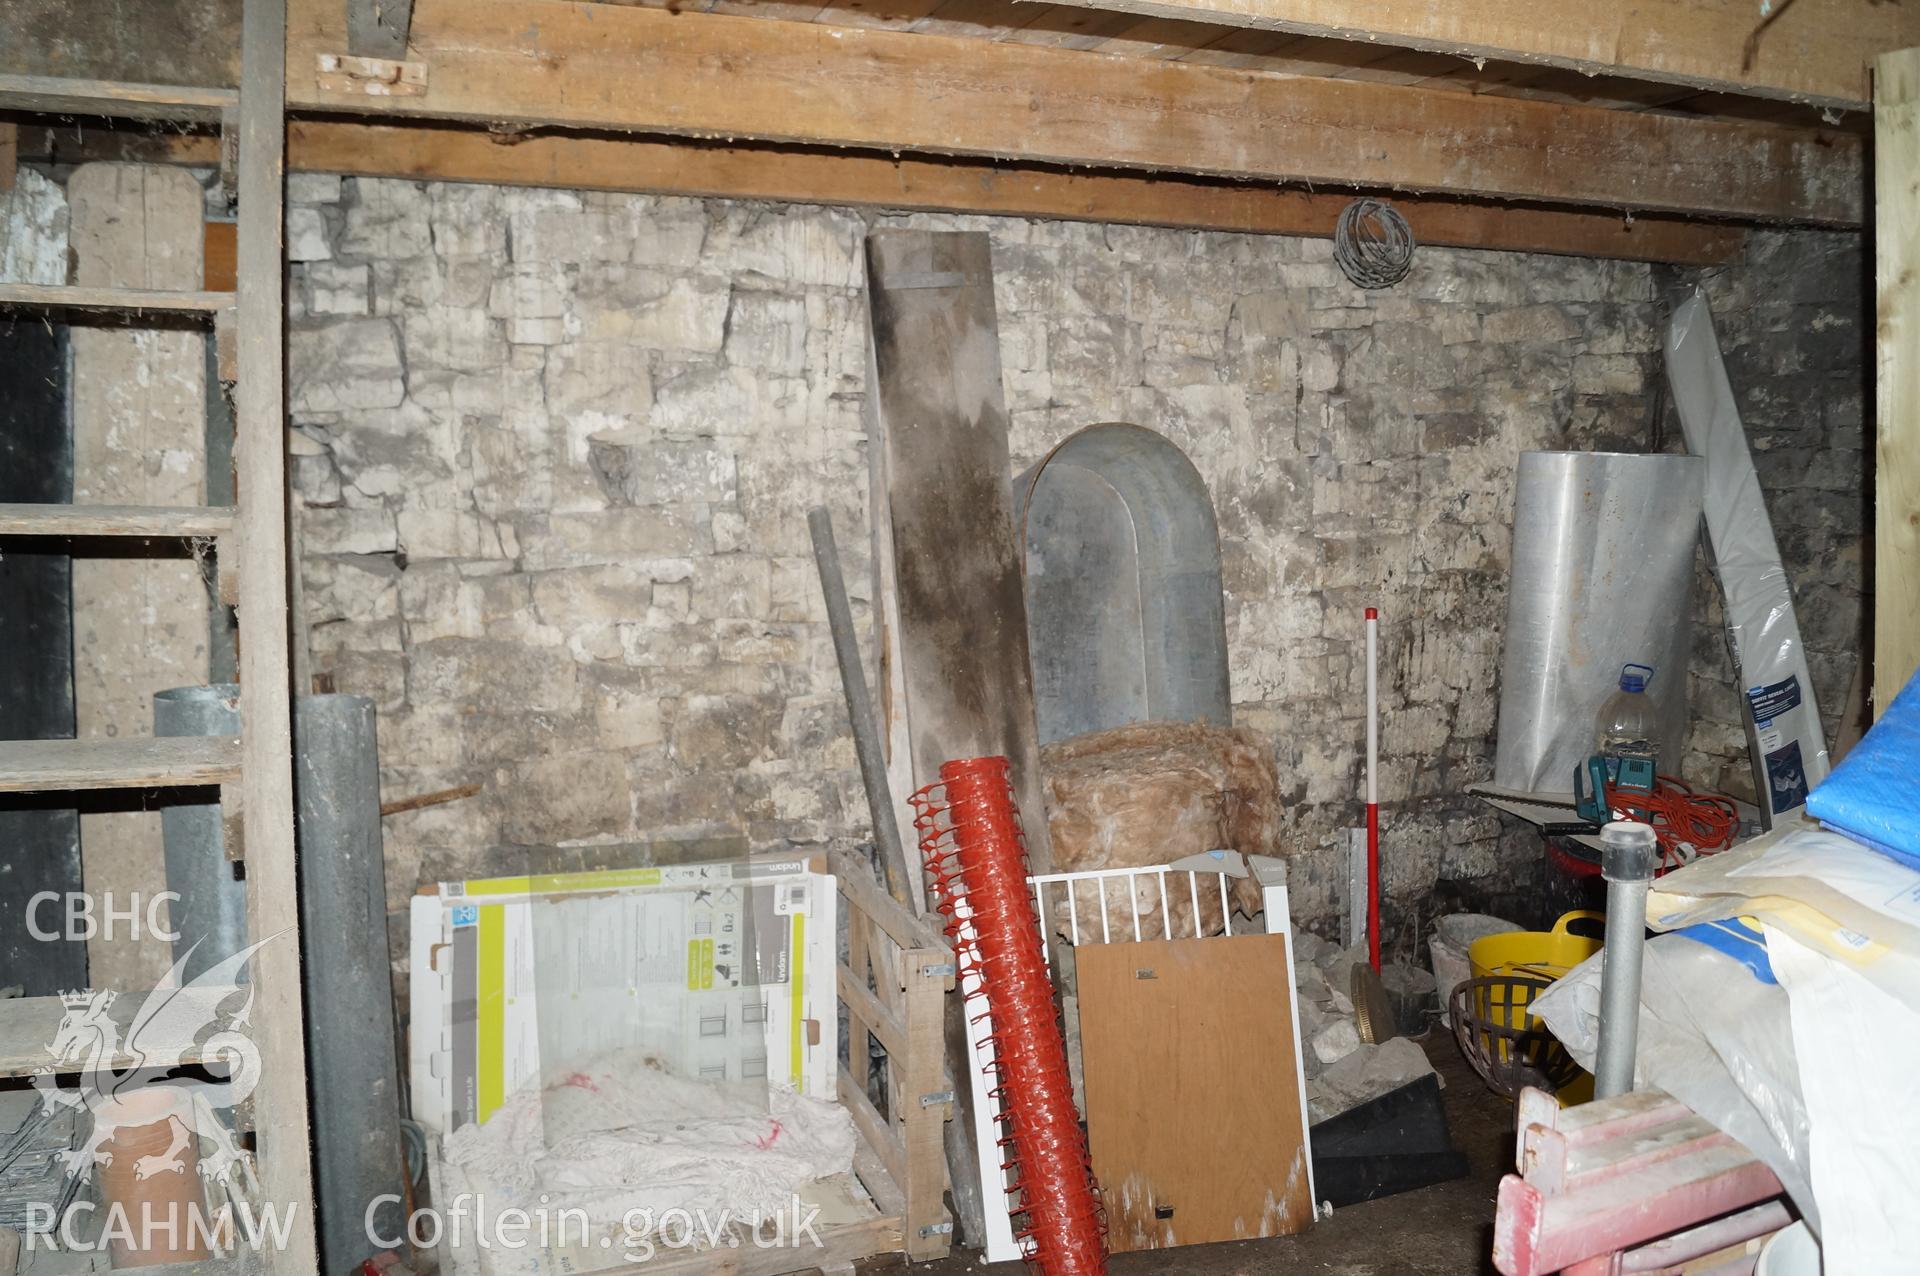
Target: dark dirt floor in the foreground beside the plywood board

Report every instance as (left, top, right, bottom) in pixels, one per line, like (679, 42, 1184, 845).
(883, 1028, 1513, 1276)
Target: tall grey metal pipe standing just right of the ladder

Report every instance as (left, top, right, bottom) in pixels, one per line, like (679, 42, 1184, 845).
(294, 695, 407, 1276)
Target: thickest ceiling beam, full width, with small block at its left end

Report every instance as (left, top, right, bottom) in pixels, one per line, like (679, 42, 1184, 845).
(288, 0, 1862, 224)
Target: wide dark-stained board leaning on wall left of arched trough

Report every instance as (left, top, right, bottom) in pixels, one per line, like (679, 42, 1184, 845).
(866, 230, 1052, 1245)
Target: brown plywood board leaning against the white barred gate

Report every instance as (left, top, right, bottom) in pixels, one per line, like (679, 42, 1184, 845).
(1073, 934, 1313, 1253)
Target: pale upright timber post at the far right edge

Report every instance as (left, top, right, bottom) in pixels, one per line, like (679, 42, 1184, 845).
(1874, 48, 1920, 718)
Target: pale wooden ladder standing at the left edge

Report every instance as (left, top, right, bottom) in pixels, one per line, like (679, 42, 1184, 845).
(0, 0, 317, 1274)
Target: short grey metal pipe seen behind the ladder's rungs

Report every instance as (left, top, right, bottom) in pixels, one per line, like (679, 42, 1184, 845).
(154, 683, 248, 981)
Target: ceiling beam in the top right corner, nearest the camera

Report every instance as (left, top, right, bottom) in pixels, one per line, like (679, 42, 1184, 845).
(1021, 0, 1920, 111)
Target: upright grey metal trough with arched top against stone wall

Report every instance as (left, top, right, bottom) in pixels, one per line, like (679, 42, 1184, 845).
(1014, 424, 1233, 744)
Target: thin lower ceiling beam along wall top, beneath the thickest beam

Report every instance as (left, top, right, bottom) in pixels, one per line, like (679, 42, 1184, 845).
(27, 119, 1745, 264)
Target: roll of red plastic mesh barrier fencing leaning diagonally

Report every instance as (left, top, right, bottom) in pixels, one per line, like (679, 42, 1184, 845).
(912, 758, 1106, 1276)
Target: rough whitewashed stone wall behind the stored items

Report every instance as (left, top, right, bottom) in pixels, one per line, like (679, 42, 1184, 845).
(288, 177, 1862, 938)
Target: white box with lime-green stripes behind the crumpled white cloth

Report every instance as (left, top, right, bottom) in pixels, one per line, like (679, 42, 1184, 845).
(409, 858, 839, 1134)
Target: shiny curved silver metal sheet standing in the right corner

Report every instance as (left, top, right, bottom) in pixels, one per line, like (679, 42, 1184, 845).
(1494, 453, 1707, 792)
